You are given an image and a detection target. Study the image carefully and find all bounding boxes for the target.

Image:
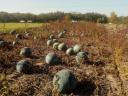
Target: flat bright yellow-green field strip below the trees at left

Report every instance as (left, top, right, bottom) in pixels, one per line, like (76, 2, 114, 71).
(0, 23, 43, 31)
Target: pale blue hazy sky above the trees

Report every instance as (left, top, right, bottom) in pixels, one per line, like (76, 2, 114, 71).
(0, 0, 128, 16)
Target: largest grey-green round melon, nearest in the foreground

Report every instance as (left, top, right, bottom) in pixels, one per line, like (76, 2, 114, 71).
(53, 69, 77, 93)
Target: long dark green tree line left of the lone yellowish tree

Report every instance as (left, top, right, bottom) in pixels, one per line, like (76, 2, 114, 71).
(0, 12, 108, 23)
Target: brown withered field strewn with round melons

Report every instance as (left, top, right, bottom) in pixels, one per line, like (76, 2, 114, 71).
(0, 20, 128, 96)
